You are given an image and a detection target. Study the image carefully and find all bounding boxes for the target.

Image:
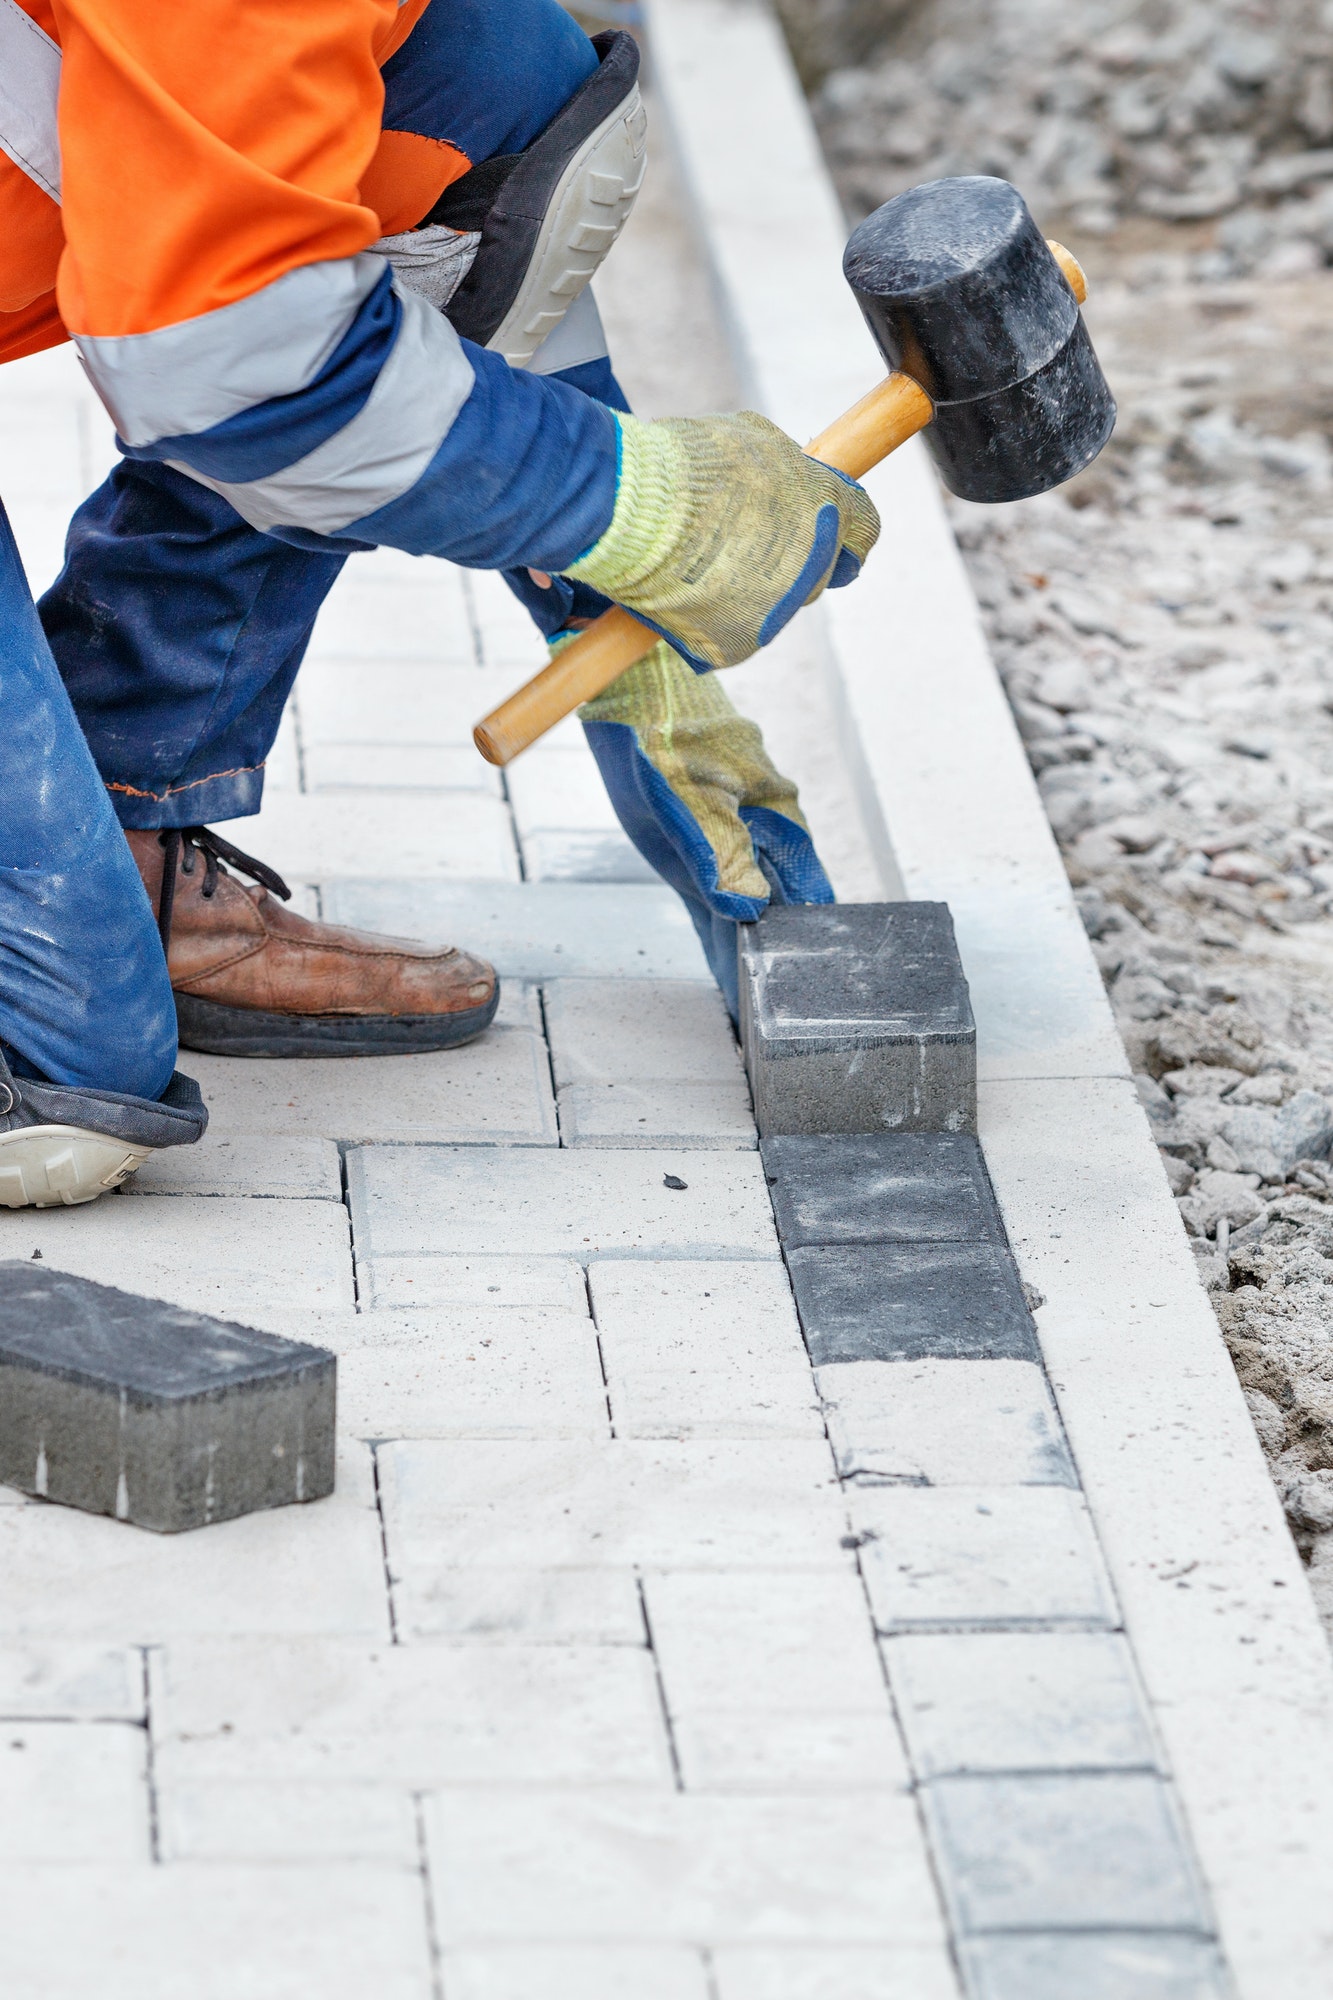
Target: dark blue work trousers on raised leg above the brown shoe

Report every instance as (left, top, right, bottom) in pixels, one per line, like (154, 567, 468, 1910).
(38, 0, 608, 828)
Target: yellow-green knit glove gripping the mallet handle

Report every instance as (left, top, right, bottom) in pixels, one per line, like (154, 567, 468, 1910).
(566, 410, 879, 672)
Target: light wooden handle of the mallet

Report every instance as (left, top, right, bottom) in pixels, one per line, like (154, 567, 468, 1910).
(472, 244, 1087, 764)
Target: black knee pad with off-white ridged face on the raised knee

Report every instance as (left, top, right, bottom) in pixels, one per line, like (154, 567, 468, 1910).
(374, 30, 646, 368)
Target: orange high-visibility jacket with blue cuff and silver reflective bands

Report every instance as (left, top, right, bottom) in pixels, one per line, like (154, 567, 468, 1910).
(0, 0, 616, 570)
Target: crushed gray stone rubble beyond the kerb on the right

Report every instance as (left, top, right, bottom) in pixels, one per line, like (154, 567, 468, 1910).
(793, 0, 1333, 1608)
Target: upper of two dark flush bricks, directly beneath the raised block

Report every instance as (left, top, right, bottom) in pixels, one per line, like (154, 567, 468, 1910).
(763, 1132, 1005, 1250)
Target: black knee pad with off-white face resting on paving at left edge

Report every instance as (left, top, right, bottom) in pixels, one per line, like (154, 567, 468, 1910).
(0, 1056, 208, 1208)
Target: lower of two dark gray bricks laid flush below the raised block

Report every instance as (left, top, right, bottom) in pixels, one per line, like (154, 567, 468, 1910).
(787, 1244, 1041, 1368)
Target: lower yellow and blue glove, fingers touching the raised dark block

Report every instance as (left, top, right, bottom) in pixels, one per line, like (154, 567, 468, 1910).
(578, 644, 835, 1018)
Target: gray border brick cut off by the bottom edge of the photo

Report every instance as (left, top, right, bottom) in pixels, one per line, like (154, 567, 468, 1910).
(961, 1932, 1233, 2000)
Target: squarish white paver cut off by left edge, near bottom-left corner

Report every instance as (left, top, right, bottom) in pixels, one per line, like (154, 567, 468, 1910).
(0, 1722, 150, 1864)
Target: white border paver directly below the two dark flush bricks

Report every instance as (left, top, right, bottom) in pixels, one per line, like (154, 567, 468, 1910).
(817, 1360, 1077, 1486)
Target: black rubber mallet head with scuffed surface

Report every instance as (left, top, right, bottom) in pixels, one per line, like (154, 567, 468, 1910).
(843, 174, 1115, 500)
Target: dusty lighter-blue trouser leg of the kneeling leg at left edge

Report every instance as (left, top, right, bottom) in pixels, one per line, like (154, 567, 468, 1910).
(0, 508, 176, 1098)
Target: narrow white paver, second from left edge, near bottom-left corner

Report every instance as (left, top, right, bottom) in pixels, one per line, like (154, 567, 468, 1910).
(158, 1772, 418, 1870)
